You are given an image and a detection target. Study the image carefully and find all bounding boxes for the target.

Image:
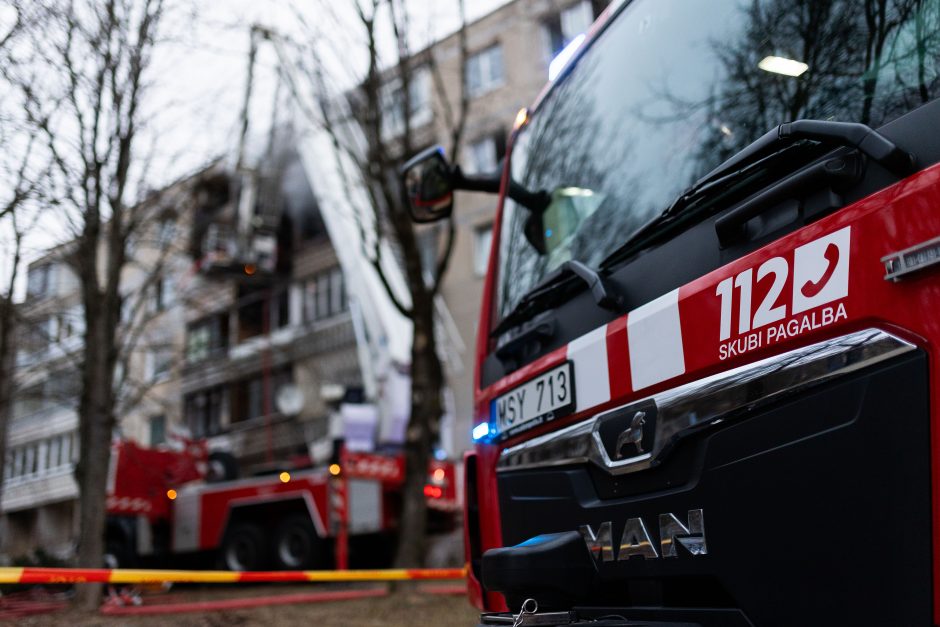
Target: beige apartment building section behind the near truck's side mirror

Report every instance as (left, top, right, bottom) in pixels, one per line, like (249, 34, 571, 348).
(392, 0, 609, 455)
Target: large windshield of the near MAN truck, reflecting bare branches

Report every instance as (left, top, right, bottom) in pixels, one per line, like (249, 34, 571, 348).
(497, 0, 940, 321)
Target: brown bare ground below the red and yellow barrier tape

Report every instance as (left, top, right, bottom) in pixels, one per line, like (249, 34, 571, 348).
(7, 586, 479, 627)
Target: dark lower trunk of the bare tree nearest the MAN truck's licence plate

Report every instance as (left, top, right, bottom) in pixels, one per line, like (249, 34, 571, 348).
(395, 292, 444, 568)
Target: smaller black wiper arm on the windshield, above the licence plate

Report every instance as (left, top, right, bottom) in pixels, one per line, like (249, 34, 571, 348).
(490, 260, 623, 337)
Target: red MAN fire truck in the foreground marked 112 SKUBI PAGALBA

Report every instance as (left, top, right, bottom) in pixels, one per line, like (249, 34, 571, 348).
(404, 0, 940, 626)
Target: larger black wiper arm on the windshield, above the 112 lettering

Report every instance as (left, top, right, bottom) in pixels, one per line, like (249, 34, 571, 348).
(600, 120, 916, 269)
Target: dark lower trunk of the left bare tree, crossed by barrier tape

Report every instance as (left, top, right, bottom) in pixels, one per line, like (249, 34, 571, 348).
(76, 301, 116, 610)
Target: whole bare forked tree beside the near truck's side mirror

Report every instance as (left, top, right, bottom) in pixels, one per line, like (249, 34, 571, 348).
(280, 0, 469, 566)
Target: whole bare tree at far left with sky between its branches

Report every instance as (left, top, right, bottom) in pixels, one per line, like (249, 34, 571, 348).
(2, 0, 165, 609)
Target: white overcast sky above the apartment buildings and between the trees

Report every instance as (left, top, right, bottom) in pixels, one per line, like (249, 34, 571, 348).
(0, 0, 508, 297)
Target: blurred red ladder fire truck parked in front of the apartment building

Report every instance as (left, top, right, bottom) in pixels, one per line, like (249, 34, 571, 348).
(107, 441, 459, 570)
